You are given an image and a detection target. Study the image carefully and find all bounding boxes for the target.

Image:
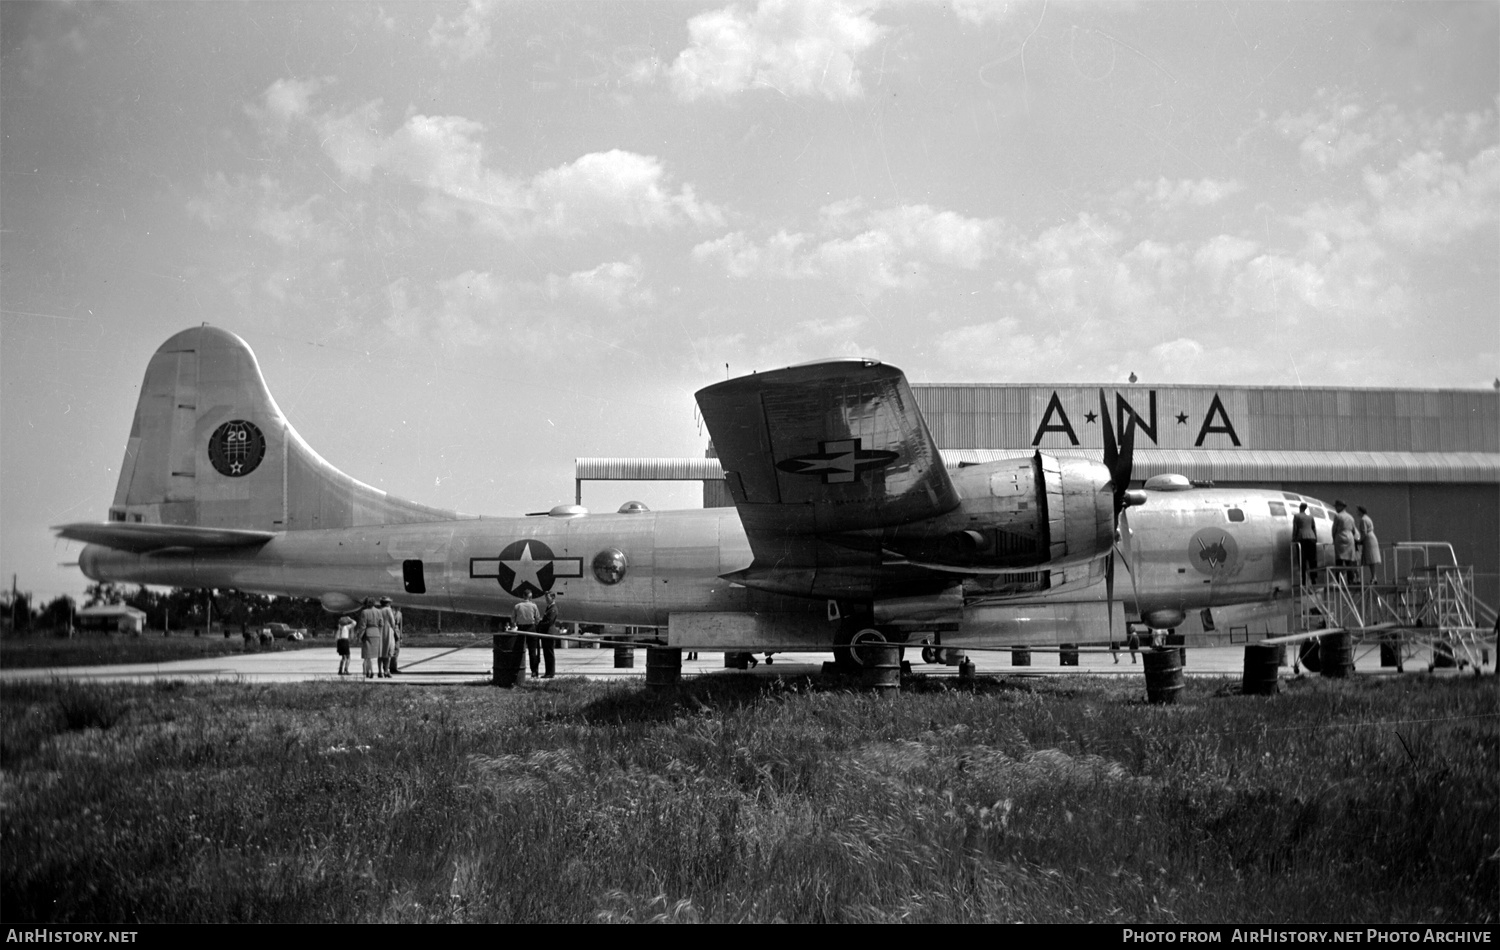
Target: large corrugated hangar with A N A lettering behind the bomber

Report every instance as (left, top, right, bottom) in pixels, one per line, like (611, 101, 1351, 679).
(578, 384, 1500, 630)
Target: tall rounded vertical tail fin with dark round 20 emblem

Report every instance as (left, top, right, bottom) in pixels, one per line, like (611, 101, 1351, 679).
(101, 326, 458, 531)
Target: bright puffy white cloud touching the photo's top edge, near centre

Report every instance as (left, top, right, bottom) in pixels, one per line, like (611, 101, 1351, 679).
(666, 0, 887, 101)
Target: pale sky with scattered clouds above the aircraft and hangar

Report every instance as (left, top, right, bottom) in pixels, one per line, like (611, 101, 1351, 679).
(0, 0, 1500, 597)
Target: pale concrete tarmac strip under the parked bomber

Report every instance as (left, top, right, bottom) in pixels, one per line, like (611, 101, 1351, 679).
(0, 639, 1494, 686)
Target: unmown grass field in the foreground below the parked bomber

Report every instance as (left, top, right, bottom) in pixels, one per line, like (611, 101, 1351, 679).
(0, 674, 1500, 923)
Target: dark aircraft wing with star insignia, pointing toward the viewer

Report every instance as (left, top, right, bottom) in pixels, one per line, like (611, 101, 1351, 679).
(698, 360, 959, 543)
